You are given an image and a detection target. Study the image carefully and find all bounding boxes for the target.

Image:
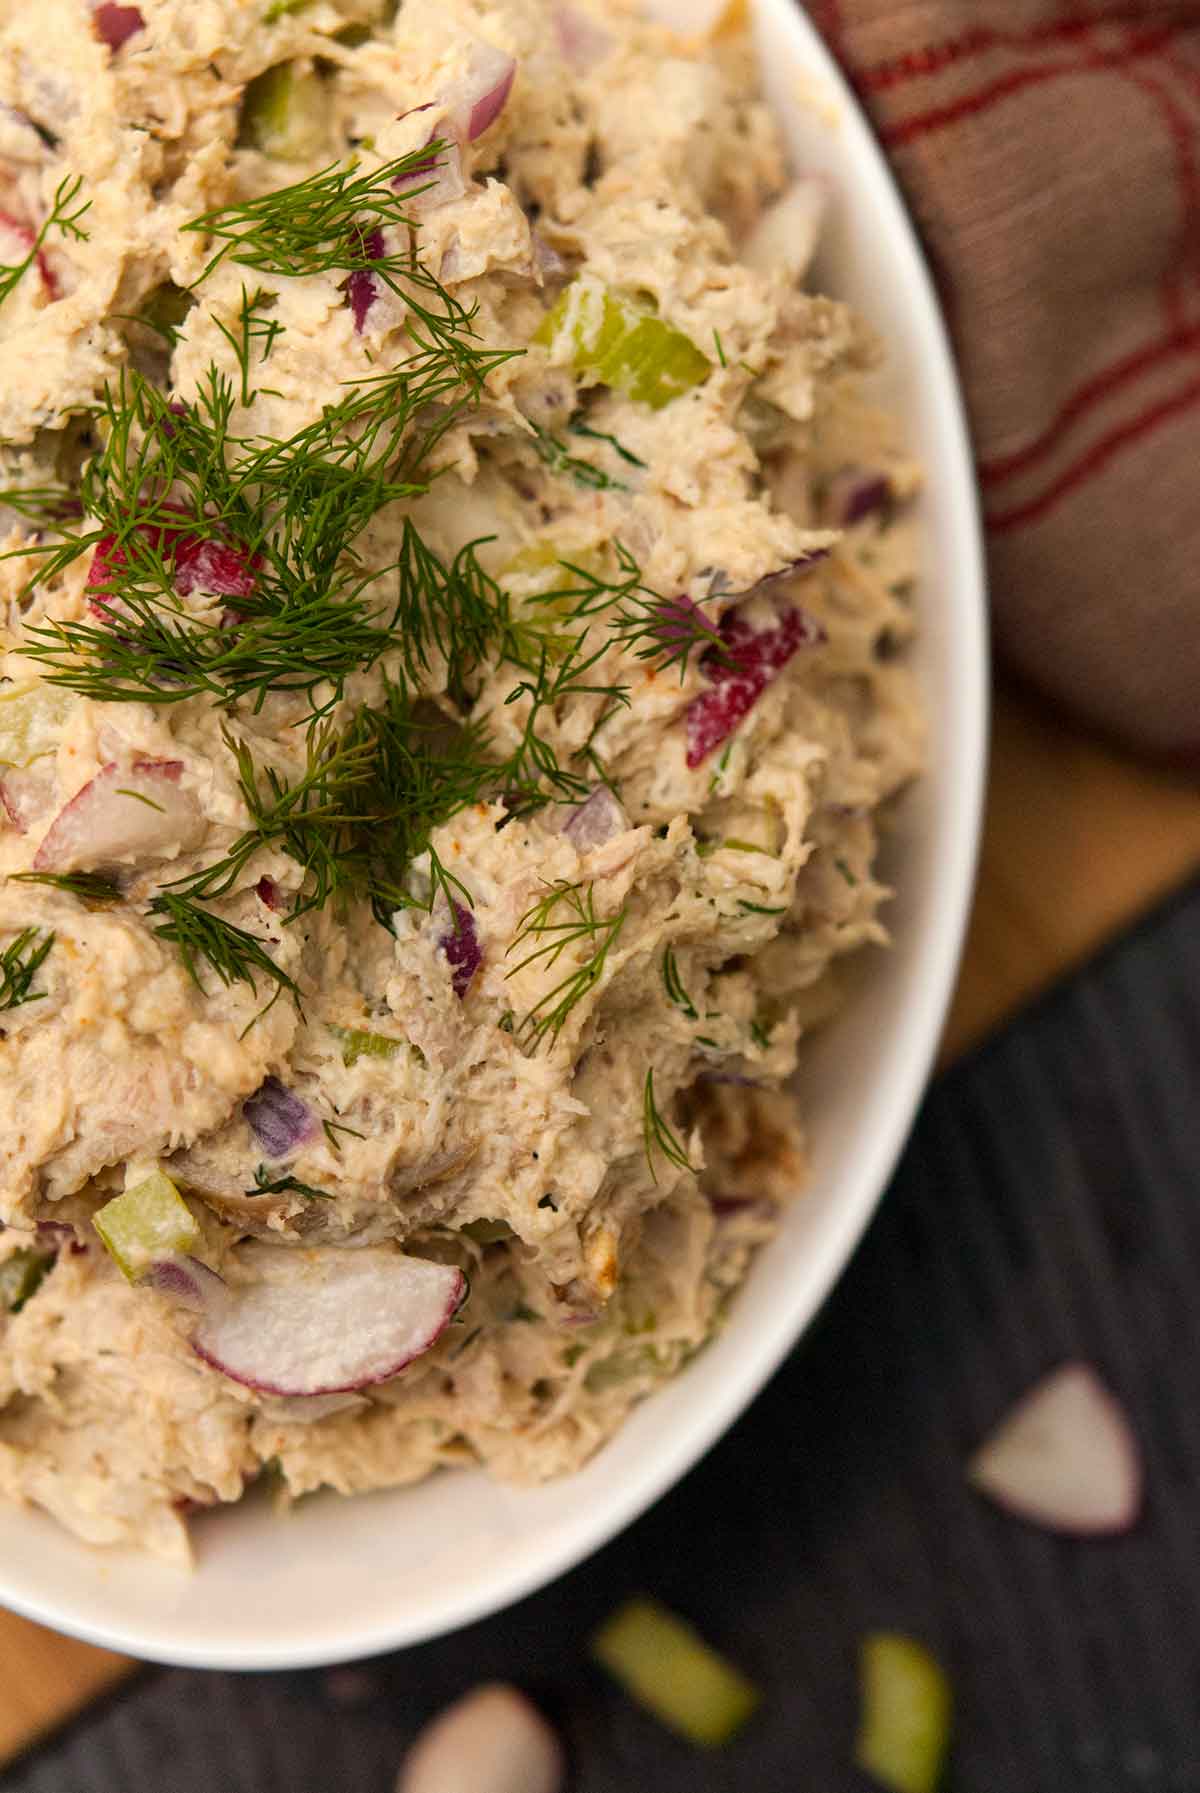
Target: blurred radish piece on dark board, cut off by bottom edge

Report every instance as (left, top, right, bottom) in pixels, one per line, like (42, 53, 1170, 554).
(396, 1682, 567, 1793)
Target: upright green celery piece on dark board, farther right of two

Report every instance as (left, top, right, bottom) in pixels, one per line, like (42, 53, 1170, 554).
(854, 1632, 952, 1793)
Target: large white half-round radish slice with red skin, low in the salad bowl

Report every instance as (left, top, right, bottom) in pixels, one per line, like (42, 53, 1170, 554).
(192, 1244, 466, 1395)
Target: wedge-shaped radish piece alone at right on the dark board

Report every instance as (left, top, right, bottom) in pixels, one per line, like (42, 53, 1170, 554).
(967, 1363, 1143, 1537)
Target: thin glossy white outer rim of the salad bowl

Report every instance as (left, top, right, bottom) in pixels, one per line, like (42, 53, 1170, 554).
(0, 0, 988, 1671)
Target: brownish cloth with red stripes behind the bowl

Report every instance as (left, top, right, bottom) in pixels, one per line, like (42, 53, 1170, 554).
(809, 0, 1200, 767)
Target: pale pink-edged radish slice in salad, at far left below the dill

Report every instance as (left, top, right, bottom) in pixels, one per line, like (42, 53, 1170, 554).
(34, 760, 204, 871)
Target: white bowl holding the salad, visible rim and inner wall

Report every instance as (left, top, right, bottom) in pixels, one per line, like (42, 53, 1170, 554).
(0, 0, 987, 1669)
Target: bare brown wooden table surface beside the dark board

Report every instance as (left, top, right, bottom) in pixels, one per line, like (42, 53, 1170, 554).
(0, 692, 1200, 1761)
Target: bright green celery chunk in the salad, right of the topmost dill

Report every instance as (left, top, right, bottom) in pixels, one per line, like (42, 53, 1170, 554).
(533, 274, 712, 411)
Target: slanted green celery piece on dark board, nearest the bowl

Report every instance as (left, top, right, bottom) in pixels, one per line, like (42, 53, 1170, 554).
(592, 1598, 759, 1750)
